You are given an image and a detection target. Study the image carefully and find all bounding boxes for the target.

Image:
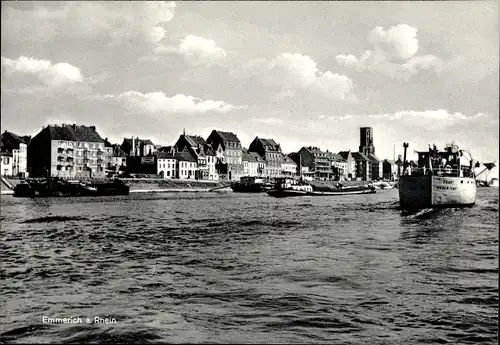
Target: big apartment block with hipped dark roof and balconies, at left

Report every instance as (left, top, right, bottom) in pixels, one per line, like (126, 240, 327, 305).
(27, 124, 106, 178)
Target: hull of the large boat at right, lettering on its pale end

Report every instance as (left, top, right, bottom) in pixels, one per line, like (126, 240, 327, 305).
(399, 175, 476, 210)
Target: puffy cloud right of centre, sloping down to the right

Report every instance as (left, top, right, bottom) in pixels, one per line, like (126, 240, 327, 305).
(263, 53, 354, 99)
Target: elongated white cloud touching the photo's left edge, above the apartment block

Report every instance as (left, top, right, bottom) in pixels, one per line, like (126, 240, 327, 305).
(2, 56, 84, 86)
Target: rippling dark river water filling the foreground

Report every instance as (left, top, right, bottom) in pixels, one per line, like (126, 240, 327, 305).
(0, 188, 499, 344)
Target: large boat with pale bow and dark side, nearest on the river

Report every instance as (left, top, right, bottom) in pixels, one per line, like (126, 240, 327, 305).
(399, 143, 482, 210)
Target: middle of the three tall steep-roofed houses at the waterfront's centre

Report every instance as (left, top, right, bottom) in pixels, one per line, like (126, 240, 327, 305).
(207, 130, 244, 180)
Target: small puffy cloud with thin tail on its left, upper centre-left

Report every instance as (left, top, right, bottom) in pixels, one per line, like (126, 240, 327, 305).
(154, 35, 226, 66)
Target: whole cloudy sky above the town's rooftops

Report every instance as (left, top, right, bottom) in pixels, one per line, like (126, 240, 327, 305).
(1, 1, 499, 172)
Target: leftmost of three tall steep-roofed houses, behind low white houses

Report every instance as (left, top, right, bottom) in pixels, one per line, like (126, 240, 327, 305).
(175, 133, 219, 180)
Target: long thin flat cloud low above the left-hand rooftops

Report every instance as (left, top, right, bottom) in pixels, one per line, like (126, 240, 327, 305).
(91, 91, 246, 114)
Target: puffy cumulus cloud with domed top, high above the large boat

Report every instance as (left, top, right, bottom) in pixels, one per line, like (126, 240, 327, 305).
(335, 24, 444, 79)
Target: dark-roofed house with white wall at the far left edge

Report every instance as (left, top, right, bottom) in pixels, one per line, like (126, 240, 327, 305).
(0, 131, 31, 177)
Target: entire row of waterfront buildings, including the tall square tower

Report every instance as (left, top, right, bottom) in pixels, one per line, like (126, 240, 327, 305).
(0, 124, 400, 181)
